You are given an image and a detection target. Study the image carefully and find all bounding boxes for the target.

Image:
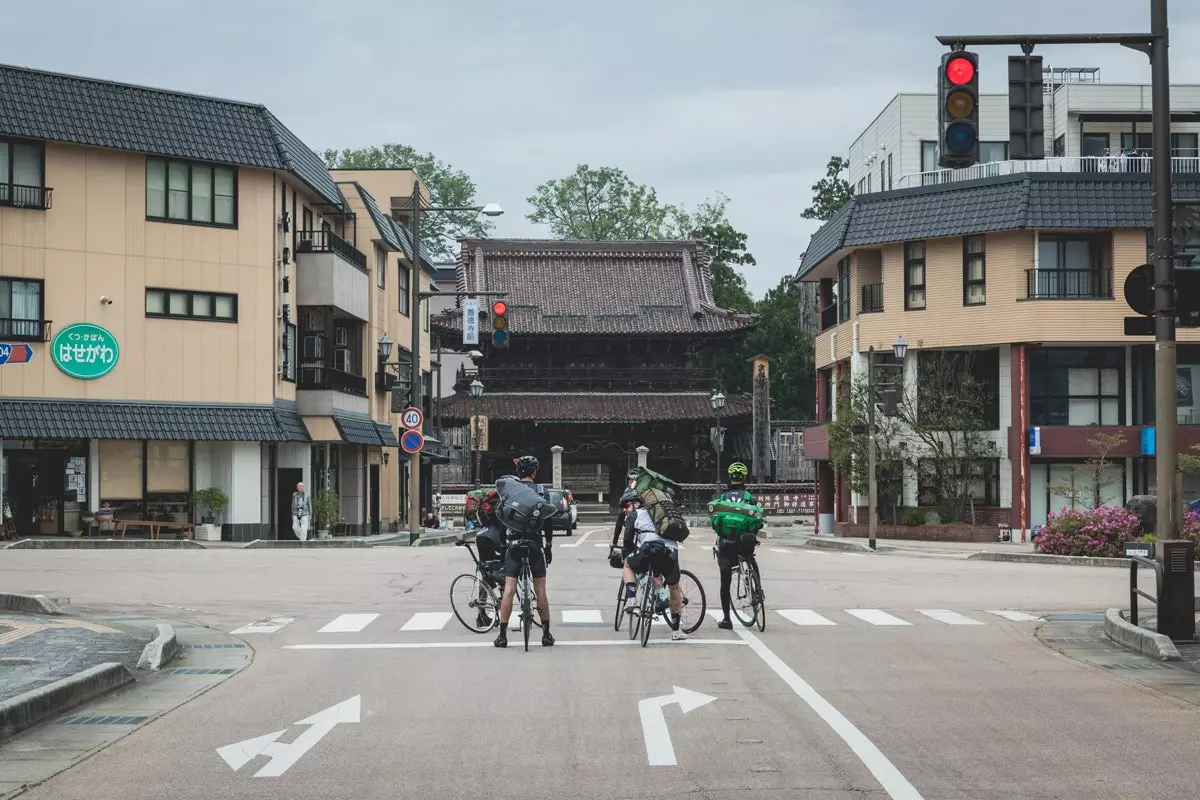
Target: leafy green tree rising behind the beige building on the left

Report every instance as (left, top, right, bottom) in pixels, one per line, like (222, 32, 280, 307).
(325, 143, 494, 260)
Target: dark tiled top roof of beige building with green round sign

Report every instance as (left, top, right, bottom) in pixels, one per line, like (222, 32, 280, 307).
(0, 65, 342, 205)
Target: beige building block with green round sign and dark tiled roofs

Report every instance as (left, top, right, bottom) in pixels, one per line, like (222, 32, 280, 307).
(0, 66, 432, 541)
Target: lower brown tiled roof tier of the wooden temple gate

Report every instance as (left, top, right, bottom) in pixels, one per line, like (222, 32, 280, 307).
(442, 392, 752, 422)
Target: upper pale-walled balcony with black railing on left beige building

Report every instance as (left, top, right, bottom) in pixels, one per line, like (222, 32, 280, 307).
(296, 230, 371, 321)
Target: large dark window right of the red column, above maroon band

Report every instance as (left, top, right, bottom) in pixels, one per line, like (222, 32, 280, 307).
(1030, 348, 1124, 425)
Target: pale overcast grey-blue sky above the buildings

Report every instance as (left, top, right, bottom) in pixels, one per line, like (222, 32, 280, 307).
(0, 0, 1200, 295)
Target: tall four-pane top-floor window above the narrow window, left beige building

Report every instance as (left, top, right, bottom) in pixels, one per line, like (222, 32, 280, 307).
(146, 158, 238, 228)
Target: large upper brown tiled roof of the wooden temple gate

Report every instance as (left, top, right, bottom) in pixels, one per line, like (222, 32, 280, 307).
(434, 239, 758, 336)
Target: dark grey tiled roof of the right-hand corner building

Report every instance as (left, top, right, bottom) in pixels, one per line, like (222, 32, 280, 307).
(797, 173, 1200, 279)
